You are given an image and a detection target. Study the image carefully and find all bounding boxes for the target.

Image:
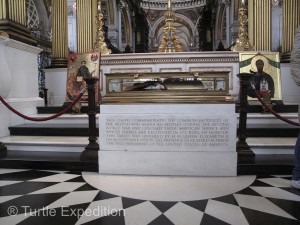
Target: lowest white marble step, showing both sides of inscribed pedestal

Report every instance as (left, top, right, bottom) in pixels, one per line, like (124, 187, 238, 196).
(0, 136, 296, 154)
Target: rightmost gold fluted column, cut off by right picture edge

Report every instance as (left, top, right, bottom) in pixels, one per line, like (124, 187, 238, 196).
(282, 0, 300, 61)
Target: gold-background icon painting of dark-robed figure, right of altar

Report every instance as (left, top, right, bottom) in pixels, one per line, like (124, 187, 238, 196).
(239, 52, 282, 100)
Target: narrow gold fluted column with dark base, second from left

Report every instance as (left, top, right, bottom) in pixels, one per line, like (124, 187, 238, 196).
(51, 0, 68, 68)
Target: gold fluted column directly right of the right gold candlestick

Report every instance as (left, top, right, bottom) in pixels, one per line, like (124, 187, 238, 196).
(249, 0, 272, 51)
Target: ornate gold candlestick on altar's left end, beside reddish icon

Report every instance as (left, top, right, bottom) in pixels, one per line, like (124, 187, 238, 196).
(93, 0, 111, 55)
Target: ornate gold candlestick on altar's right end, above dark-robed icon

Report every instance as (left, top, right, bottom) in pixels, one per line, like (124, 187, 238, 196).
(231, 5, 254, 51)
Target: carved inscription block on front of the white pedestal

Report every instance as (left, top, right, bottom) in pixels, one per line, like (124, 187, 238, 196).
(99, 114, 236, 151)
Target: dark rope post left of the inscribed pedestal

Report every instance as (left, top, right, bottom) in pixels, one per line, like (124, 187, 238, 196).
(80, 77, 99, 161)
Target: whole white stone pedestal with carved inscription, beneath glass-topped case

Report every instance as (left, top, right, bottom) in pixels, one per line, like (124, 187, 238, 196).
(99, 104, 237, 176)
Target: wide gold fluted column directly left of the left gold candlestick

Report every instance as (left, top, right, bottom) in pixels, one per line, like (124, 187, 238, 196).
(76, 0, 97, 53)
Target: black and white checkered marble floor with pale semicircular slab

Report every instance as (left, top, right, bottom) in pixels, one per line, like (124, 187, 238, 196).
(0, 169, 300, 225)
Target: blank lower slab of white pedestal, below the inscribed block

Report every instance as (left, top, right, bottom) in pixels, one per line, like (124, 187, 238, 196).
(99, 151, 237, 176)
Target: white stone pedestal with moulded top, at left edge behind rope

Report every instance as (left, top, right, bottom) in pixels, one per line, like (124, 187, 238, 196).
(0, 36, 43, 137)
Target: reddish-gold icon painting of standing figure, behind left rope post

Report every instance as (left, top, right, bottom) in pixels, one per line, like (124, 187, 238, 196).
(65, 52, 101, 103)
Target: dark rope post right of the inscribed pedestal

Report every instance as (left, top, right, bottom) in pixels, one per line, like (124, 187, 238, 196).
(236, 73, 255, 162)
